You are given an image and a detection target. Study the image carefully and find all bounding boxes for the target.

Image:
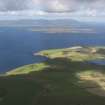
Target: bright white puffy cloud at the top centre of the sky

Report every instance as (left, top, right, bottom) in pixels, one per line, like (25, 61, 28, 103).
(43, 0, 77, 12)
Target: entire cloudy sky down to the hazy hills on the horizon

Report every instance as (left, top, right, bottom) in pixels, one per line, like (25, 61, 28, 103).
(0, 0, 105, 20)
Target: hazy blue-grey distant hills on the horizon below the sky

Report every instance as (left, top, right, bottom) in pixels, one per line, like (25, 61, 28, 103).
(0, 19, 83, 26)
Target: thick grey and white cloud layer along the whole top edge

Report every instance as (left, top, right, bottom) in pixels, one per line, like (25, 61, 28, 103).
(0, 0, 105, 15)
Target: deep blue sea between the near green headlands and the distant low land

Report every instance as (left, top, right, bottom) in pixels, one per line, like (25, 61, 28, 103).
(0, 27, 105, 72)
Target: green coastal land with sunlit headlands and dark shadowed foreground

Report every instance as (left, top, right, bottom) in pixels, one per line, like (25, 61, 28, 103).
(0, 46, 105, 105)
